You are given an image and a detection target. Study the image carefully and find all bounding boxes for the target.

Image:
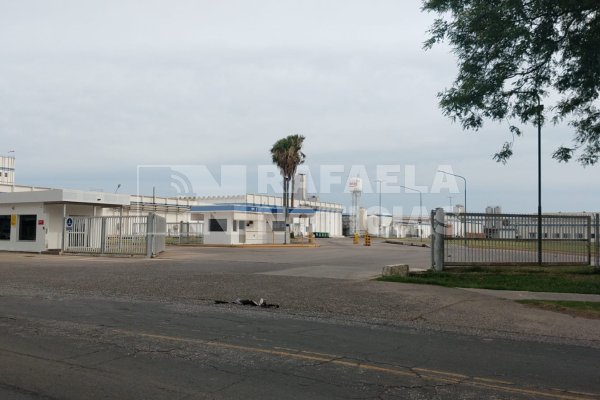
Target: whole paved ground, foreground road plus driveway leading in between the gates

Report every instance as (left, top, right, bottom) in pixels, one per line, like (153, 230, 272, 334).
(0, 241, 600, 399)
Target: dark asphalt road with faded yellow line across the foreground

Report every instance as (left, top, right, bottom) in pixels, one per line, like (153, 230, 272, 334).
(0, 290, 600, 399)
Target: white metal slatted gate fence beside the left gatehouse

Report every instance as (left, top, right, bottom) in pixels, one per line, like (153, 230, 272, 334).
(63, 214, 166, 256)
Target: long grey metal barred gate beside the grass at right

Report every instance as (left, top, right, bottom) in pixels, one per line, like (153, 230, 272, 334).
(432, 213, 598, 266)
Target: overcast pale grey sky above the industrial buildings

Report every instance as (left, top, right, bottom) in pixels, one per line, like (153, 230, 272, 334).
(0, 0, 600, 212)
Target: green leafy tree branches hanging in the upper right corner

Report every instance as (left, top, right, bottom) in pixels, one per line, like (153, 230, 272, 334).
(423, 0, 600, 165)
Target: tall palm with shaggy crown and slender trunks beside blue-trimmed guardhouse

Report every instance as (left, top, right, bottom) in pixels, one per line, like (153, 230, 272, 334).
(271, 135, 306, 243)
